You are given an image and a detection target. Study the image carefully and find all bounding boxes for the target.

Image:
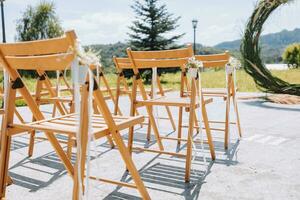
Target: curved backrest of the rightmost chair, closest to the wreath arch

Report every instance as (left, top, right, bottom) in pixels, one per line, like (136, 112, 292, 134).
(195, 51, 230, 68)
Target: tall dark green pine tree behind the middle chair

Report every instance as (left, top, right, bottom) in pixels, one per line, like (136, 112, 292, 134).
(128, 0, 184, 50)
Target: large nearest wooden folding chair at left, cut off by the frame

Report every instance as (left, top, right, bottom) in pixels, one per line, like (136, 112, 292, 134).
(0, 31, 150, 200)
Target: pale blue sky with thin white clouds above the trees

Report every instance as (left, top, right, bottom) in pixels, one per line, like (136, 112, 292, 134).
(1, 0, 300, 46)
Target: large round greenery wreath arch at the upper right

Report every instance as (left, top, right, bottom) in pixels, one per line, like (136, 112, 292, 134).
(241, 0, 300, 96)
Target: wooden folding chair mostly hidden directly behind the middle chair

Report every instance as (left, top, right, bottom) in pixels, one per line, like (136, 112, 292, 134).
(113, 56, 176, 141)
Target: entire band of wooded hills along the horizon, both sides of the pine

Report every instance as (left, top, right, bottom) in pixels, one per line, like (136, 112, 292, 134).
(89, 29, 300, 71)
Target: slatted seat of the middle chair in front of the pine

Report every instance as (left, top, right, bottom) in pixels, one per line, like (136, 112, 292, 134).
(137, 96, 213, 107)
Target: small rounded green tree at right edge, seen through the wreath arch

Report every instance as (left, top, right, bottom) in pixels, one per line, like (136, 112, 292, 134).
(282, 43, 300, 68)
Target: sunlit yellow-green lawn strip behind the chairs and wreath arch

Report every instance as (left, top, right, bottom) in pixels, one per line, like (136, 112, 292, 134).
(0, 69, 300, 106)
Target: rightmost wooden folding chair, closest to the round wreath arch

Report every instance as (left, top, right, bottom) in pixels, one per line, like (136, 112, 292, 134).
(195, 51, 242, 149)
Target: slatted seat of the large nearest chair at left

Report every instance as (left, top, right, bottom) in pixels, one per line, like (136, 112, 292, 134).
(11, 113, 144, 139)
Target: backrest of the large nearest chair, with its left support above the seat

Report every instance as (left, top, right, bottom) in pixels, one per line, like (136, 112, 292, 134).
(0, 31, 76, 120)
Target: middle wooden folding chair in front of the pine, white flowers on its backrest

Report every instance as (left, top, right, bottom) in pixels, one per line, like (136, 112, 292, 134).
(127, 46, 215, 182)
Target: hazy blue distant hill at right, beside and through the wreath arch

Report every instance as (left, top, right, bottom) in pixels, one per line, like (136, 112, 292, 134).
(214, 28, 300, 63)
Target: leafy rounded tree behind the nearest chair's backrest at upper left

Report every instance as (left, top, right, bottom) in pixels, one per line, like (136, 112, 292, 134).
(16, 1, 64, 41)
